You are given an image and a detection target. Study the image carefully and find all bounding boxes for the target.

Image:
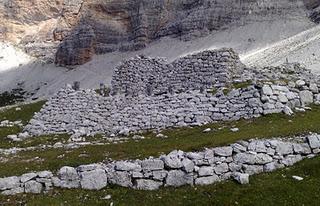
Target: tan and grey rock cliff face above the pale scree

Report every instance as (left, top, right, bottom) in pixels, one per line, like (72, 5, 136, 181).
(0, 0, 320, 66)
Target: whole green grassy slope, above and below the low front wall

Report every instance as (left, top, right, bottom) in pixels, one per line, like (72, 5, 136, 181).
(0, 103, 320, 205)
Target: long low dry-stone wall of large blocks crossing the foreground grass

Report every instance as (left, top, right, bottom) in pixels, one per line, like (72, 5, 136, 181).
(0, 134, 320, 195)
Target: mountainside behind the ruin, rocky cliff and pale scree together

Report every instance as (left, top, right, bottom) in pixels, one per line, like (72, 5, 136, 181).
(0, 0, 320, 97)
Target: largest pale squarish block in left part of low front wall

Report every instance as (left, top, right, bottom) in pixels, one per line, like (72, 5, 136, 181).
(80, 169, 108, 190)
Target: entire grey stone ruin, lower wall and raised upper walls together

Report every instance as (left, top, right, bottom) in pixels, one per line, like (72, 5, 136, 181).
(24, 49, 320, 138)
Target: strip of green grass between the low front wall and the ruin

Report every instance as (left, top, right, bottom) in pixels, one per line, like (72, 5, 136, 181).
(0, 106, 320, 177)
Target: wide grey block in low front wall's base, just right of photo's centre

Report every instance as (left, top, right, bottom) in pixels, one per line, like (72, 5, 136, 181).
(166, 170, 193, 187)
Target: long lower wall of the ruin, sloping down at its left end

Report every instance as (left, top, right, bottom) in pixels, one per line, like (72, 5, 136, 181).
(24, 80, 320, 136)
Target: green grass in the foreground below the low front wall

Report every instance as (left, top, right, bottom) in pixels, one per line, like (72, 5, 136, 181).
(0, 157, 320, 206)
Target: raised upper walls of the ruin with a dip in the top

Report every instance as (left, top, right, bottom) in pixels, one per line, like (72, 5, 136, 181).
(112, 48, 244, 95)
